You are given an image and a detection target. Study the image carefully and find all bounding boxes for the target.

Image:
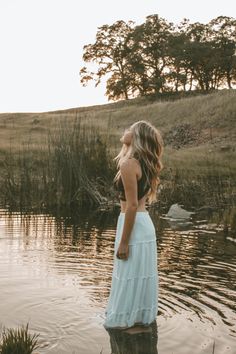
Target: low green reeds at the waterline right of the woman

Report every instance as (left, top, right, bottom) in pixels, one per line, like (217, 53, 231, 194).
(158, 162, 236, 209)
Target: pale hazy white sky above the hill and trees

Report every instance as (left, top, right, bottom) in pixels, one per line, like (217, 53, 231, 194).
(0, 0, 236, 112)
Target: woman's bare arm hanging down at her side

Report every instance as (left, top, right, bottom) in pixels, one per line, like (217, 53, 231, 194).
(117, 159, 138, 259)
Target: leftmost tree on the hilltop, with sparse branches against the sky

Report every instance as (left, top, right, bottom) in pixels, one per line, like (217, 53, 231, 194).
(80, 21, 134, 99)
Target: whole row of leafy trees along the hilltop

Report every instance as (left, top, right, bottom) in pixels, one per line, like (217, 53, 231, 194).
(80, 14, 236, 100)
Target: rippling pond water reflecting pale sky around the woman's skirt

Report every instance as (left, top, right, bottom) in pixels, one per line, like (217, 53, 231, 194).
(0, 209, 236, 354)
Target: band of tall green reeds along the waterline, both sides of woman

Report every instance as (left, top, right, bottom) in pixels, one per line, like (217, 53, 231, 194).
(0, 113, 236, 214)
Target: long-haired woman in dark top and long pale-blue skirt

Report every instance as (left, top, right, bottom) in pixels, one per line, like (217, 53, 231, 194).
(104, 120, 163, 332)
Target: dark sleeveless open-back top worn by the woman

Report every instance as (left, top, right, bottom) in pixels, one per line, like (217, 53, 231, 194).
(114, 160, 150, 201)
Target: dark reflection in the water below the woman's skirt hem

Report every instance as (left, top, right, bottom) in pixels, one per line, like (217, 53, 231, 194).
(106, 321, 158, 354)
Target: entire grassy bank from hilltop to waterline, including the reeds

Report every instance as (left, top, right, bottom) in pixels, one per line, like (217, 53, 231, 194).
(0, 90, 236, 231)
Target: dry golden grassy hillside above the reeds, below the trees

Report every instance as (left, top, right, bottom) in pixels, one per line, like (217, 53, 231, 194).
(0, 90, 236, 172)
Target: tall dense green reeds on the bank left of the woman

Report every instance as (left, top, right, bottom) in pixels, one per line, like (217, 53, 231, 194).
(2, 117, 114, 212)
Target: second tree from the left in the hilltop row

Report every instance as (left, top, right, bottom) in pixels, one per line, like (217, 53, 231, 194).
(127, 14, 172, 96)
